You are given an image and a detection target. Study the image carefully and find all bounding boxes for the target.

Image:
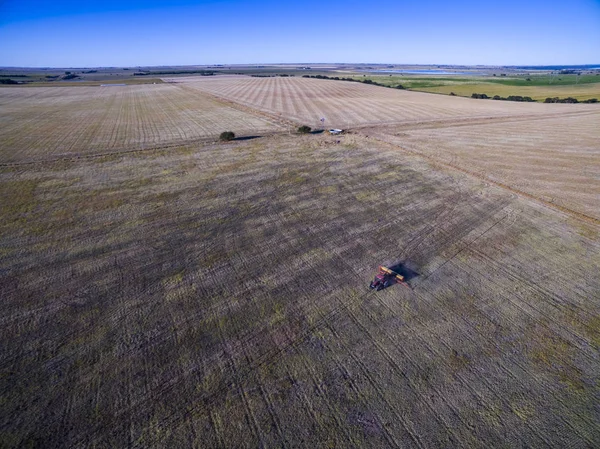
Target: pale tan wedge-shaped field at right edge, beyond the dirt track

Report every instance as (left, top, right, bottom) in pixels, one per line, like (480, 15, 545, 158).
(369, 111, 600, 220)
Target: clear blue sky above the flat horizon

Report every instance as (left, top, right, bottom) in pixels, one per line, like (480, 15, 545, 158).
(0, 0, 600, 67)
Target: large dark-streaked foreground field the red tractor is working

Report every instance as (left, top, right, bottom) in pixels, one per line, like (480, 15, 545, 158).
(0, 131, 600, 448)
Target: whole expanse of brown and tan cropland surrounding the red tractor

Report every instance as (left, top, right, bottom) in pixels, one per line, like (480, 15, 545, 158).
(0, 77, 600, 449)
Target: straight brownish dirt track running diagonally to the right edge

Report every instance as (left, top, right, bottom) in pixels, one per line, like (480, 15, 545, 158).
(361, 134, 600, 226)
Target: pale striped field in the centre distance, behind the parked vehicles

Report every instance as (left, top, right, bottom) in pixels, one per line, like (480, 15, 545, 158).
(165, 76, 598, 128)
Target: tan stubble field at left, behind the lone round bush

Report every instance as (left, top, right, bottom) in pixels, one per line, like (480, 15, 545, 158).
(0, 84, 281, 163)
